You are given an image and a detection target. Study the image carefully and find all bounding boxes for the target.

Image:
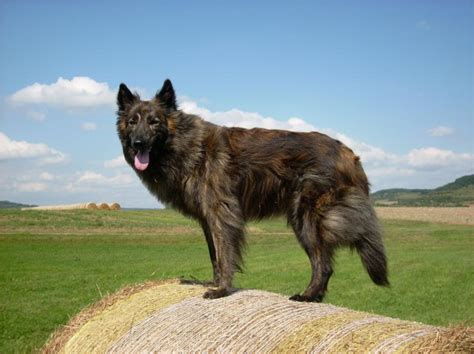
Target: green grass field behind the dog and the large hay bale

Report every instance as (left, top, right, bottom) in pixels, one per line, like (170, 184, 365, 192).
(0, 210, 474, 353)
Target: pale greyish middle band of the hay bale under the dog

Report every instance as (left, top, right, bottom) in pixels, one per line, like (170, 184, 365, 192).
(109, 290, 345, 353)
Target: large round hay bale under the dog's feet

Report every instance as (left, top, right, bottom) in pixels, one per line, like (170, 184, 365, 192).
(43, 280, 474, 353)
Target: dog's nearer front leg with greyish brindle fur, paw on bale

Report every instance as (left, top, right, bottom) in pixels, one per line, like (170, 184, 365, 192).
(204, 202, 244, 299)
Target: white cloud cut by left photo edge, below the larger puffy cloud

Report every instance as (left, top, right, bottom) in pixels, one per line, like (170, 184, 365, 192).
(0, 132, 66, 164)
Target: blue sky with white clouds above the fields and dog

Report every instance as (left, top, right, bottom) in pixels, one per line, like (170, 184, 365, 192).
(0, 0, 474, 207)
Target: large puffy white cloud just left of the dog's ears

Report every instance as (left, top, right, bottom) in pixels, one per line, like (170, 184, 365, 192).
(9, 76, 115, 110)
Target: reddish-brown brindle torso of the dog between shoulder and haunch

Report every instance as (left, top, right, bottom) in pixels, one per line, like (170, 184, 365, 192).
(223, 128, 369, 219)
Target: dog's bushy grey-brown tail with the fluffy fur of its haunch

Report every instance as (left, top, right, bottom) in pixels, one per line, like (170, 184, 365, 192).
(322, 188, 389, 286)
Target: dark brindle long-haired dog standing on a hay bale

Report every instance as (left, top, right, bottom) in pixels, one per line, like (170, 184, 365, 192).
(117, 80, 389, 302)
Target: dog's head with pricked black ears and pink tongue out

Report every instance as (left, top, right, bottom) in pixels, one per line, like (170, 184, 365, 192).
(117, 80, 177, 171)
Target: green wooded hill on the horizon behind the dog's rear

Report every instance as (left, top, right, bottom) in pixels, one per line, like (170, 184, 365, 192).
(371, 175, 474, 206)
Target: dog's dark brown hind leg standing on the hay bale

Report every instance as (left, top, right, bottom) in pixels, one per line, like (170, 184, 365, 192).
(289, 194, 333, 302)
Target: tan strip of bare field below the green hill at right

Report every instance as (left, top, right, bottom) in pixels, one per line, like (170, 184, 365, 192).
(375, 206, 474, 225)
